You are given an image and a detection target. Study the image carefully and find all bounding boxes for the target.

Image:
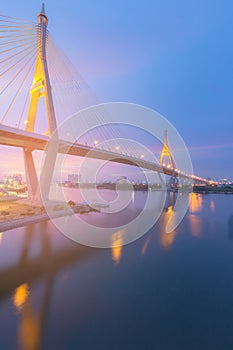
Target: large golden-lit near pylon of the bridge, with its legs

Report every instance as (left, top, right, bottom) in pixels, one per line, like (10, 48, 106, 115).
(24, 4, 57, 202)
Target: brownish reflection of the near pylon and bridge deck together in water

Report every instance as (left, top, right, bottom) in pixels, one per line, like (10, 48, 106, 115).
(0, 222, 95, 350)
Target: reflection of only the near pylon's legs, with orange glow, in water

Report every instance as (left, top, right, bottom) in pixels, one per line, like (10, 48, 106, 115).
(9, 222, 54, 350)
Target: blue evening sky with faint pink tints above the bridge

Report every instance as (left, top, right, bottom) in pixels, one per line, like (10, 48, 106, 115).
(0, 0, 233, 179)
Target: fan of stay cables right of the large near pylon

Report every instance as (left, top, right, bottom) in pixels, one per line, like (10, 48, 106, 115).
(47, 34, 145, 157)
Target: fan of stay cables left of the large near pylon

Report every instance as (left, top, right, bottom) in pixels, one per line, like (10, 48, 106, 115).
(0, 15, 38, 129)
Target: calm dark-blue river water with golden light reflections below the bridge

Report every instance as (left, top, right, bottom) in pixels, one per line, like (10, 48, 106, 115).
(0, 190, 233, 350)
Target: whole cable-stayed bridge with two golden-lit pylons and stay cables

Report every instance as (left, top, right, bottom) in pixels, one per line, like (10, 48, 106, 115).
(0, 5, 214, 201)
